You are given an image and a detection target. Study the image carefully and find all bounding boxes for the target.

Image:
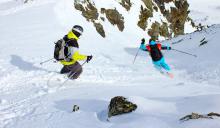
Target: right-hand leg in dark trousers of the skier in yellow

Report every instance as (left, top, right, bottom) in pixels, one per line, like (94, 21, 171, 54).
(68, 62, 82, 79)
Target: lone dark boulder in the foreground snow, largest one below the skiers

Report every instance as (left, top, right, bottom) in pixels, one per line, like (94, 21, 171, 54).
(108, 96, 137, 117)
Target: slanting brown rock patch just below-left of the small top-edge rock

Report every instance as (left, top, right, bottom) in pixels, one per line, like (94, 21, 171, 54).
(102, 9, 124, 31)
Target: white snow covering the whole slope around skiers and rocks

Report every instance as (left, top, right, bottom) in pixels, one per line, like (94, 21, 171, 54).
(0, 0, 220, 128)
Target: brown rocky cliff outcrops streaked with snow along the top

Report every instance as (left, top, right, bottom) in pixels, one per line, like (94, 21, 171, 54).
(74, 0, 195, 39)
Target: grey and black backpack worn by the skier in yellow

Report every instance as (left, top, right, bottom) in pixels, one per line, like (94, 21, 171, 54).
(54, 39, 65, 61)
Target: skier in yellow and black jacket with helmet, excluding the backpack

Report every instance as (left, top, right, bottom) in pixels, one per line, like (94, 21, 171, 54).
(57, 25, 92, 79)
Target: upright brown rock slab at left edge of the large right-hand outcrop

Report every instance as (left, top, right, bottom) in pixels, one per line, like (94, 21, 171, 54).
(138, 6, 153, 31)
